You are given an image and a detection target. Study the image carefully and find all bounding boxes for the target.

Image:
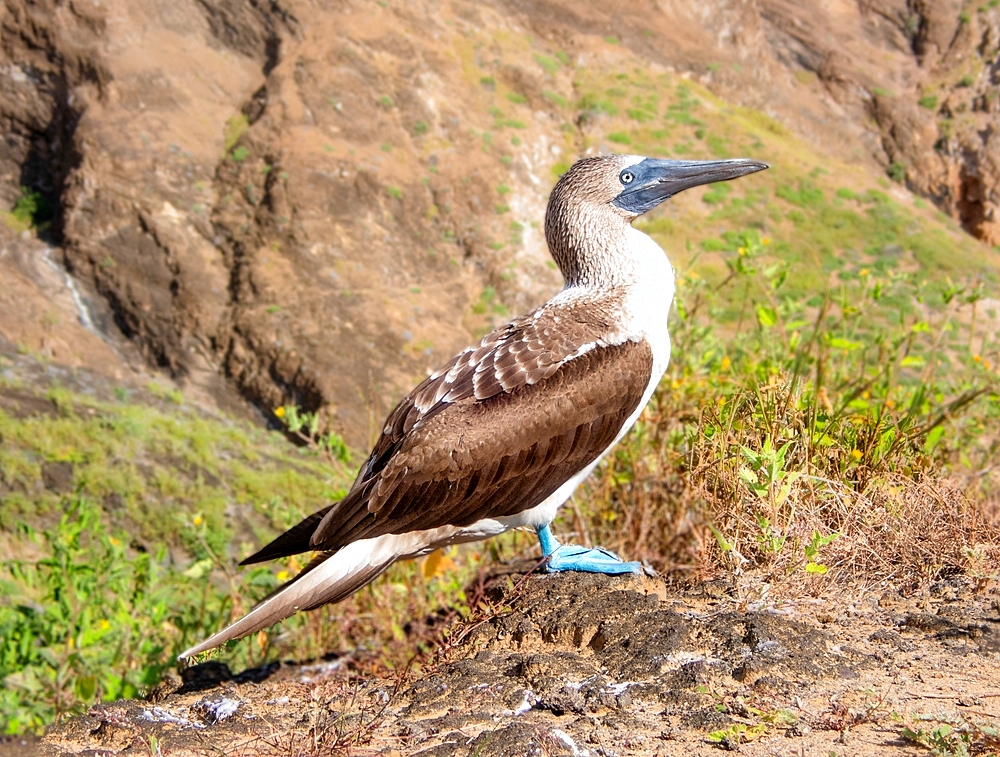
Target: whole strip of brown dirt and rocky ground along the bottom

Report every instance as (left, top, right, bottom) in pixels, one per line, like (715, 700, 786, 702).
(9, 574, 1000, 757)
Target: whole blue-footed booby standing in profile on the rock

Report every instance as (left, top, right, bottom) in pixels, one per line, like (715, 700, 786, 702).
(180, 154, 769, 659)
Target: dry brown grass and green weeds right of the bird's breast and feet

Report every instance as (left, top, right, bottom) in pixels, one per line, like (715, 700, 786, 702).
(564, 232, 1000, 596)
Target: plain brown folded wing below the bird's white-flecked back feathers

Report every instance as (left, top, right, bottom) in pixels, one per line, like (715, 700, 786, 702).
(310, 342, 653, 550)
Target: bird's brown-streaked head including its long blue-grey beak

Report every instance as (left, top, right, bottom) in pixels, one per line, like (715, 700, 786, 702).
(545, 155, 769, 279)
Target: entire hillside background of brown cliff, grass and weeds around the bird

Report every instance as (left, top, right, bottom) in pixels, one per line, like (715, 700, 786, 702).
(0, 0, 1000, 732)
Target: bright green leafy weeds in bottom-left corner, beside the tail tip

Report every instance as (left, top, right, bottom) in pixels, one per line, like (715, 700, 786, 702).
(0, 497, 275, 733)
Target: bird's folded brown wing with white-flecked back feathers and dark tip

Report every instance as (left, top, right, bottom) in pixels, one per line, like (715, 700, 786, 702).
(244, 298, 652, 563)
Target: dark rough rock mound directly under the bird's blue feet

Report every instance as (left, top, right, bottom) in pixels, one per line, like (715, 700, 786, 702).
(401, 574, 865, 733)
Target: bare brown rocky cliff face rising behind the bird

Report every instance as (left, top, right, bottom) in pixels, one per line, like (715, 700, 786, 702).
(0, 0, 1000, 444)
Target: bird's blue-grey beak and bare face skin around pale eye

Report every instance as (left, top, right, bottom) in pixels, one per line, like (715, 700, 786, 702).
(612, 158, 770, 215)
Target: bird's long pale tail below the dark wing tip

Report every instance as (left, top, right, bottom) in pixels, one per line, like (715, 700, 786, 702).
(180, 534, 411, 659)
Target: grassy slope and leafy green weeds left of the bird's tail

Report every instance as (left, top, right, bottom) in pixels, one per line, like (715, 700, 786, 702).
(0, 384, 348, 733)
